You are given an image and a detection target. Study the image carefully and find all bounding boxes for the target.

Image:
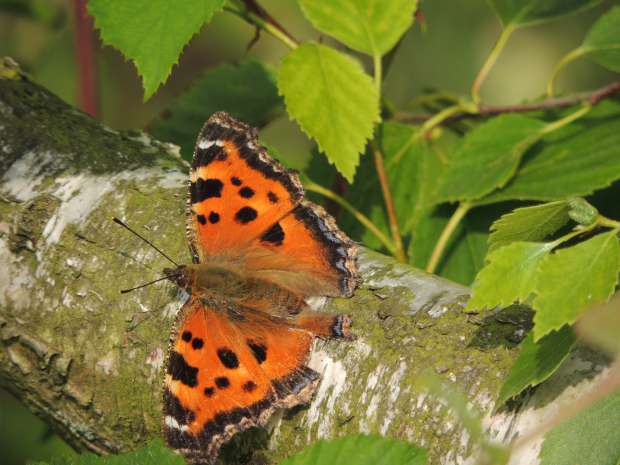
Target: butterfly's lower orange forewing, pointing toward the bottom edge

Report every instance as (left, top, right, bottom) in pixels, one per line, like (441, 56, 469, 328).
(163, 297, 318, 464)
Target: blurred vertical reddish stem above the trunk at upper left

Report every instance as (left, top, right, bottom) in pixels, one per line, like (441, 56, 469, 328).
(73, 0, 97, 117)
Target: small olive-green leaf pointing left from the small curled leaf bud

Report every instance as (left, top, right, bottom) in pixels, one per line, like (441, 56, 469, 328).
(489, 200, 569, 250)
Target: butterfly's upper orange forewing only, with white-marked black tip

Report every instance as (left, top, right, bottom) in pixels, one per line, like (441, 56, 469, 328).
(188, 113, 303, 262)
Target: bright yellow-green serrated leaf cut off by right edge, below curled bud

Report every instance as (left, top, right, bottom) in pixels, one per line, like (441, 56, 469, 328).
(532, 231, 620, 340)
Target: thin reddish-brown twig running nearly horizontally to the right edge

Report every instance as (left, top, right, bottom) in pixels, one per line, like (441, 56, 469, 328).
(394, 81, 620, 123)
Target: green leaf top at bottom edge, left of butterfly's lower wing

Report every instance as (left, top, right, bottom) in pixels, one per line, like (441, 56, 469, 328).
(32, 440, 185, 465)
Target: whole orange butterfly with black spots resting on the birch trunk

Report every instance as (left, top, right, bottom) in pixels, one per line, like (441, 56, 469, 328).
(163, 112, 358, 465)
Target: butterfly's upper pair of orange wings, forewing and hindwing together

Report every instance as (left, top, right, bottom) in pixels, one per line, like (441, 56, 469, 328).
(188, 113, 357, 296)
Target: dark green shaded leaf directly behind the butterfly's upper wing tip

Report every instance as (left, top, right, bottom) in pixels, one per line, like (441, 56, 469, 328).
(151, 61, 284, 160)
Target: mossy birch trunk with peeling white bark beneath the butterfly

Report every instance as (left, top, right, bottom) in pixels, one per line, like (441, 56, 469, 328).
(0, 60, 606, 464)
